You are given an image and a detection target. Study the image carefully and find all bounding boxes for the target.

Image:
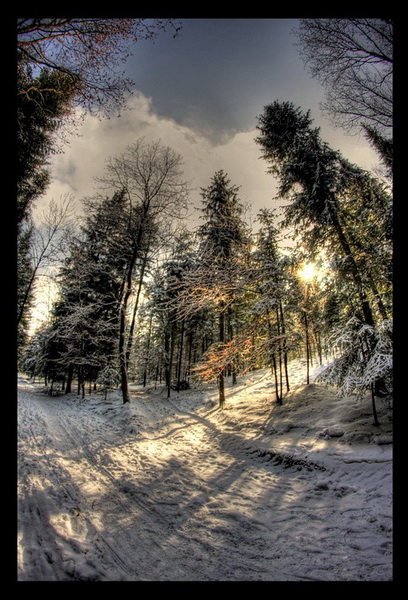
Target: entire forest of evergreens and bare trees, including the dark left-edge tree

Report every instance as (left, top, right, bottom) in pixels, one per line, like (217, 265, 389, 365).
(17, 19, 393, 422)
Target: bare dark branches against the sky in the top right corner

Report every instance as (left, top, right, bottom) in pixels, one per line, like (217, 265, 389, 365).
(297, 18, 393, 134)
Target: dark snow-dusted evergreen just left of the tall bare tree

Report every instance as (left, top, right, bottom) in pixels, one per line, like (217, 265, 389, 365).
(38, 191, 135, 391)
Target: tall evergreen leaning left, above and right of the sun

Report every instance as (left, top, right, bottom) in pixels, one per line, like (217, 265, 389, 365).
(257, 102, 392, 325)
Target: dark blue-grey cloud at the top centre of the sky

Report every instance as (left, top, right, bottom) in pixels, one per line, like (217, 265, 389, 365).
(128, 19, 320, 143)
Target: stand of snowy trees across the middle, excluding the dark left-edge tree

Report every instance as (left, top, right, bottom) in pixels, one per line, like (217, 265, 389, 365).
(21, 112, 392, 422)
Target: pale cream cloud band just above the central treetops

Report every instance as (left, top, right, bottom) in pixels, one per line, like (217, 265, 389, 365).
(38, 94, 377, 232)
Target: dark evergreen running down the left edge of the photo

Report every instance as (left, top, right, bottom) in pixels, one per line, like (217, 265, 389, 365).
(16, 53, 78, 352)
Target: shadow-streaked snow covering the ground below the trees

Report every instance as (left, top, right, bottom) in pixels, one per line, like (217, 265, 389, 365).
(18, 360, 393, 582)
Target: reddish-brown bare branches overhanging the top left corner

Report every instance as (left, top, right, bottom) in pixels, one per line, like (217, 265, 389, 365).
(17, 17, 180, 113)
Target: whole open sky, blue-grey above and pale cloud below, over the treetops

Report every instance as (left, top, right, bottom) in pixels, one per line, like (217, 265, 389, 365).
(39, 18, 377, 223)
